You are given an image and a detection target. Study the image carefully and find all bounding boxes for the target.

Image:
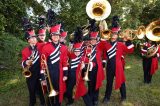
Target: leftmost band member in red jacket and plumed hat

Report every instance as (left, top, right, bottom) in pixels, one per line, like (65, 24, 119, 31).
(22, 30, 45, 106)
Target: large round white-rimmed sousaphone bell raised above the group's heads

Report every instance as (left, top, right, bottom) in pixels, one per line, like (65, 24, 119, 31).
(86, 0, 111, 21)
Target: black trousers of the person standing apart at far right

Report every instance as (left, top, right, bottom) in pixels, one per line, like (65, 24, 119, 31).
(143, 58, 152, 83)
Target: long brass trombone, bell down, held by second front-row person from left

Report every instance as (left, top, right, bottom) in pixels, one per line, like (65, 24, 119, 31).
(41, 54, 58, 97)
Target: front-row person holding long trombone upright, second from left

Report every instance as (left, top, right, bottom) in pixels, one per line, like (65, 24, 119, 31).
(41, 24, 68, 106)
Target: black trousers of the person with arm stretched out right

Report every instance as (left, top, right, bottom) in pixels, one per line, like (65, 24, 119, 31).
(105, 66, 126, 100)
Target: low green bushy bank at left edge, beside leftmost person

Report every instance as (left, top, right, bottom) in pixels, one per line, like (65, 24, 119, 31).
(0, 34, 26, 71)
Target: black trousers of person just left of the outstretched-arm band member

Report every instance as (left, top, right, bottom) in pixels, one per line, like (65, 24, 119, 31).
(88, 68, 99, 104)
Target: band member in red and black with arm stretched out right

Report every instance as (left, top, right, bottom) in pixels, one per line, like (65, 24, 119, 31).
(99, 28, 134, 103)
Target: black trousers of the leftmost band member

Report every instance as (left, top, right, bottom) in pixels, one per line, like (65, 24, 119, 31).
(26, 76, 45, 106)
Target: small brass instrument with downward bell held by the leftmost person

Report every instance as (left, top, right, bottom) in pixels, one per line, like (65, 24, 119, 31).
(22, 51, 34, 78)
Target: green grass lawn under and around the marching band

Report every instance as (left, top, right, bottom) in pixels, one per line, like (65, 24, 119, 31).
(0, 55, 160, 106)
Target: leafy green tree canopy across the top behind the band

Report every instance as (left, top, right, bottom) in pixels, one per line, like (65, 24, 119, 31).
(0, 0, 160, 37)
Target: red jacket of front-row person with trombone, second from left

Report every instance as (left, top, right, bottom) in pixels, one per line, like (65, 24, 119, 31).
(42, 42, 68, 103)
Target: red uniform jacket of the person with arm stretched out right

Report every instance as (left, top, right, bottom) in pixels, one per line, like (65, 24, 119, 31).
(99, 41, 134, 89)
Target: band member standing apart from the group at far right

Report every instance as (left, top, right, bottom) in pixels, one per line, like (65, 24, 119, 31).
(141, 38, 159, 84)
